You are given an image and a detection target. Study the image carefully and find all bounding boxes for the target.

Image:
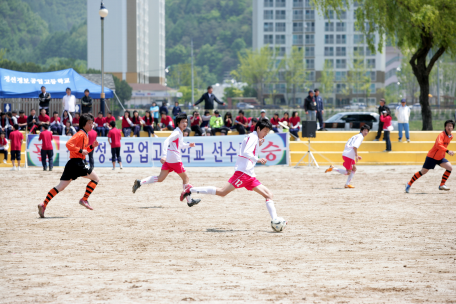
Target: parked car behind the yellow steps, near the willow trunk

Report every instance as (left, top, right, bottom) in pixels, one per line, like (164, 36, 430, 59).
(325, 112, 398, 131)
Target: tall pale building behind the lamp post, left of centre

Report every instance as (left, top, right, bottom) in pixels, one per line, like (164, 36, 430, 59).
(87, 0, 165, 84)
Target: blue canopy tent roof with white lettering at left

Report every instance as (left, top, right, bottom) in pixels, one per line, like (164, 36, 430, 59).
(0, 69, 113, 99)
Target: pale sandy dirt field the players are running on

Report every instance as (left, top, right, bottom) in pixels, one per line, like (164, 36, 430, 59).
(0, 166, 456, 303)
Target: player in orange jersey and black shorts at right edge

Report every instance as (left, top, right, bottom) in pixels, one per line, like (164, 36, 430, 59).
(405, 120, 455, 193)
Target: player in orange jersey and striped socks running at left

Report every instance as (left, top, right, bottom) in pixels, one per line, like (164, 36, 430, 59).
(38, 113, 100, 217)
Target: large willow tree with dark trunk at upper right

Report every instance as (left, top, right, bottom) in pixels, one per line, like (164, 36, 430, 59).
(313, 0, 456, 130)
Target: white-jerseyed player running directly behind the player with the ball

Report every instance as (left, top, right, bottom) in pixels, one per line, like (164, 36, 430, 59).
(133, 113, 201, 207)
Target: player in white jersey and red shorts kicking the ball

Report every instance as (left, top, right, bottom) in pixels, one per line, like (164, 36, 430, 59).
(180, 118, 286, 229)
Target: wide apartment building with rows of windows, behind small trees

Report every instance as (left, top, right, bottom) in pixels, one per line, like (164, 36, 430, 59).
(253, 0, 385, 107)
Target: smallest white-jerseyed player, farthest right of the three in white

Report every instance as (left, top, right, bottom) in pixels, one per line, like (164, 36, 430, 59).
(325, 125, 370, 188)
